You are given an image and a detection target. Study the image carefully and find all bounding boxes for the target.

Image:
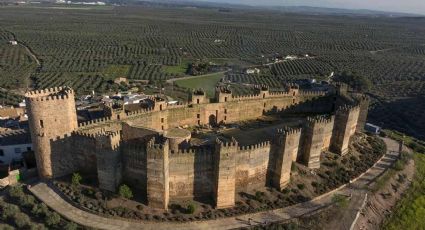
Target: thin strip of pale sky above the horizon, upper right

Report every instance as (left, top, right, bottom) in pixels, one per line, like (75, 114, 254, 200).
(198, 0, 425, 14)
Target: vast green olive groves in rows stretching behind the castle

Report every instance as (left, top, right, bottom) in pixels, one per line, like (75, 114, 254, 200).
(0, 5, 425, 138)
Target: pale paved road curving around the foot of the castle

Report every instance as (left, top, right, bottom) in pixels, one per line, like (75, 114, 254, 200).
(30, 137, 398, 230)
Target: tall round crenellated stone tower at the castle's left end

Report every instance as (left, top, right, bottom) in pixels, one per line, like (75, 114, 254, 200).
(25, 87, 78, 179)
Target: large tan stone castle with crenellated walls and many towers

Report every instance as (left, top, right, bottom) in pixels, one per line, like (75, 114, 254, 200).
(26, 84, 369, 209)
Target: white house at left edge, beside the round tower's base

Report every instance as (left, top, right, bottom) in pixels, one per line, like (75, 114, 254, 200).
(0, 129, 32, 164)
